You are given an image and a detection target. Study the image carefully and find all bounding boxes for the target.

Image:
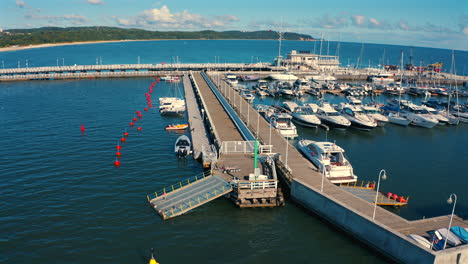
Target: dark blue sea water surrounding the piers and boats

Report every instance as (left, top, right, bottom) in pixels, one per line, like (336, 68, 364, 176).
(0, 41, 468, 263)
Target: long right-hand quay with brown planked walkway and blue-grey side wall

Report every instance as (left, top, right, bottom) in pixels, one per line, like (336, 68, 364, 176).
(209, 73, 468, 264)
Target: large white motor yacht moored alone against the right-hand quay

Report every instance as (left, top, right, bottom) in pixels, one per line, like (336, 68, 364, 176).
(298, 140, 358, 184)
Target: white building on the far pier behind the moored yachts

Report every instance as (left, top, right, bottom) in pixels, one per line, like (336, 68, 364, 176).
(282, 50, 340, 71)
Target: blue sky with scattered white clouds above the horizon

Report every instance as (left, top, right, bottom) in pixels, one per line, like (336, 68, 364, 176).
(0, 0, 468, 51)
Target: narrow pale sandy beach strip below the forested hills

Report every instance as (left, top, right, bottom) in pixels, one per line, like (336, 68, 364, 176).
(0, 39, 315, 52)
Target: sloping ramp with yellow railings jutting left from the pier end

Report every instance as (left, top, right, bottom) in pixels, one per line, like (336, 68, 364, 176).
(147, 174, 232, 220)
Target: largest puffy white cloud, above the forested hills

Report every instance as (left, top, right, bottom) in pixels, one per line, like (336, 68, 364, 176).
(116, 5, 239, 29)
